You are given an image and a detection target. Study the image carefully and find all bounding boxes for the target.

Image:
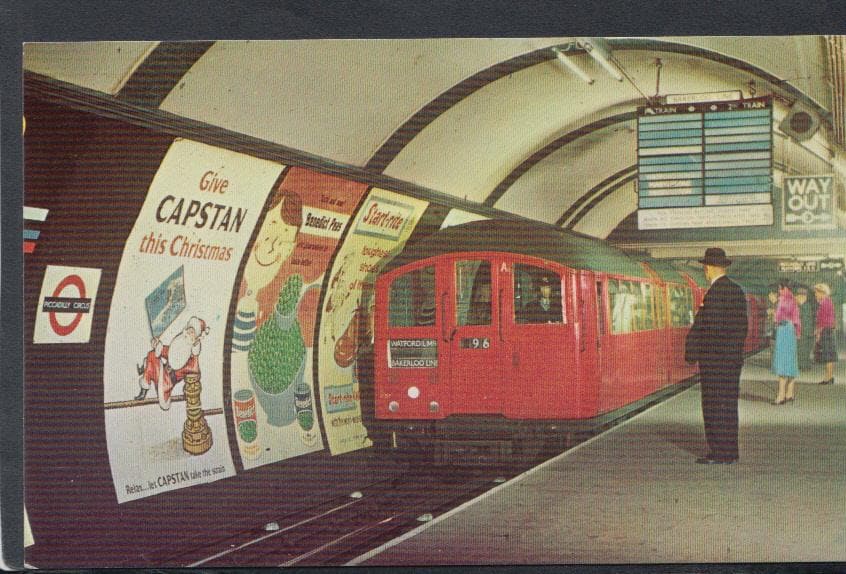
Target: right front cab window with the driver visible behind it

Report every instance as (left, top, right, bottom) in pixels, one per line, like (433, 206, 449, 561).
(514, 263, 564, 324)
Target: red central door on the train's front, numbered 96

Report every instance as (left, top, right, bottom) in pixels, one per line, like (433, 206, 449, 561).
(450, 257, 503, 414)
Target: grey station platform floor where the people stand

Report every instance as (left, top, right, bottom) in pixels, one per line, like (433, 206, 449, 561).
(350, 351, 846, 566)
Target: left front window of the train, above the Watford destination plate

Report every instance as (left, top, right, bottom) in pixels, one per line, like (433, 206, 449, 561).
(388, 266, 435, 327)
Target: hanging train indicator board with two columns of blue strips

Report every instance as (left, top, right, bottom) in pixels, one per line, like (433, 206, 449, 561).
(637, 98, 773, 229)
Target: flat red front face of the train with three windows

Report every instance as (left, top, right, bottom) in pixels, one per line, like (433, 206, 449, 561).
(375, 251, 592, 419)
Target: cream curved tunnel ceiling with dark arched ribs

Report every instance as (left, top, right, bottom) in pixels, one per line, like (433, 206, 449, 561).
(24, 36, 844, 241)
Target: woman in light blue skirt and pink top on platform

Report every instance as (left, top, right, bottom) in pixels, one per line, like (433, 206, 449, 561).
(772, 279, 802, 405)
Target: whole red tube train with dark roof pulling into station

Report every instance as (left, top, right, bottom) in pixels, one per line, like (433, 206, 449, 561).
(373, 221, 759, 450)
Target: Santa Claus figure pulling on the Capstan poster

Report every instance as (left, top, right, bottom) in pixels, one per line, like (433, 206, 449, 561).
(135, 317, 209, 411)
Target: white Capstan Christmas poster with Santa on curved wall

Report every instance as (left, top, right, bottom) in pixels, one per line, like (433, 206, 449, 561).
(103, 139, 283, 503)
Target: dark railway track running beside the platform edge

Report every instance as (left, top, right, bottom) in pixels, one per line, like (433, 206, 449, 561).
(167, 381, 704, 568)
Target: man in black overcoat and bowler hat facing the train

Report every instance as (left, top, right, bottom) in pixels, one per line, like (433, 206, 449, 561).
(684, 247, 747, 464)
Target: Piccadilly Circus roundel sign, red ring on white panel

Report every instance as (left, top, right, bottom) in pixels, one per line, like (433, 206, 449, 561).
(32, 265, 100, 343)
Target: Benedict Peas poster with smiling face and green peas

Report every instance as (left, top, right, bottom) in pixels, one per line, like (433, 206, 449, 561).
(231, 168, 367, 469)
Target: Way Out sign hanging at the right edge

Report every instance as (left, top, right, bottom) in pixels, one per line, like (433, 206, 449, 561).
(782, 175, 834, 231)
